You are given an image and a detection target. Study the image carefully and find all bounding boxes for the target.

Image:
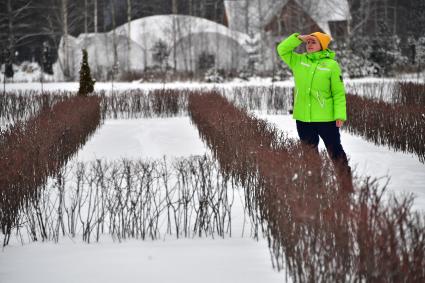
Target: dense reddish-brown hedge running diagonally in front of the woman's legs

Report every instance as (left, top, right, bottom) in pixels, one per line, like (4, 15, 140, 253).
(189, 92, 425, 282)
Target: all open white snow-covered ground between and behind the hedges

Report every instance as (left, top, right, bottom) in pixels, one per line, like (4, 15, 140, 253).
(0, 79, 425, 283)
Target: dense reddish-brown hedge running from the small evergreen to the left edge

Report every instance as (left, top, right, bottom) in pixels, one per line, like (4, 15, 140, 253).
(0, 97, 101, 244)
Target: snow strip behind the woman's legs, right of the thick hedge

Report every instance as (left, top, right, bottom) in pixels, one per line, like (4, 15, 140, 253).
(256, 113, 425, 211)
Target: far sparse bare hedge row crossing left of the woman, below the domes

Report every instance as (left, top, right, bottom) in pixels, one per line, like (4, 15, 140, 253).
(0, 86, 292, 123)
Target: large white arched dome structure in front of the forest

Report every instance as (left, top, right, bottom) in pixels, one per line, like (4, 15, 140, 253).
(55, 15, 249, 79)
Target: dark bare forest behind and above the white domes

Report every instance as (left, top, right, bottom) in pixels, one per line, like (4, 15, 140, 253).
(0, 0, 224, 66)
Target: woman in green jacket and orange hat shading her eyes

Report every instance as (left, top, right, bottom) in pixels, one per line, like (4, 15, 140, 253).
(277, 32, 353, 191)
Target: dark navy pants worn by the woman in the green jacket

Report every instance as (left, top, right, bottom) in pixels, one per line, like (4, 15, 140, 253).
(297, 120, 353, 191)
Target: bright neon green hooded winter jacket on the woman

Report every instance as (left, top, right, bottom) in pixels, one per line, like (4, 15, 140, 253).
(277, 33, 347, 122)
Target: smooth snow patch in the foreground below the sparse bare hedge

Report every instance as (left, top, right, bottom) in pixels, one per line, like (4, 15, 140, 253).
(0, 238, 285, 283)
